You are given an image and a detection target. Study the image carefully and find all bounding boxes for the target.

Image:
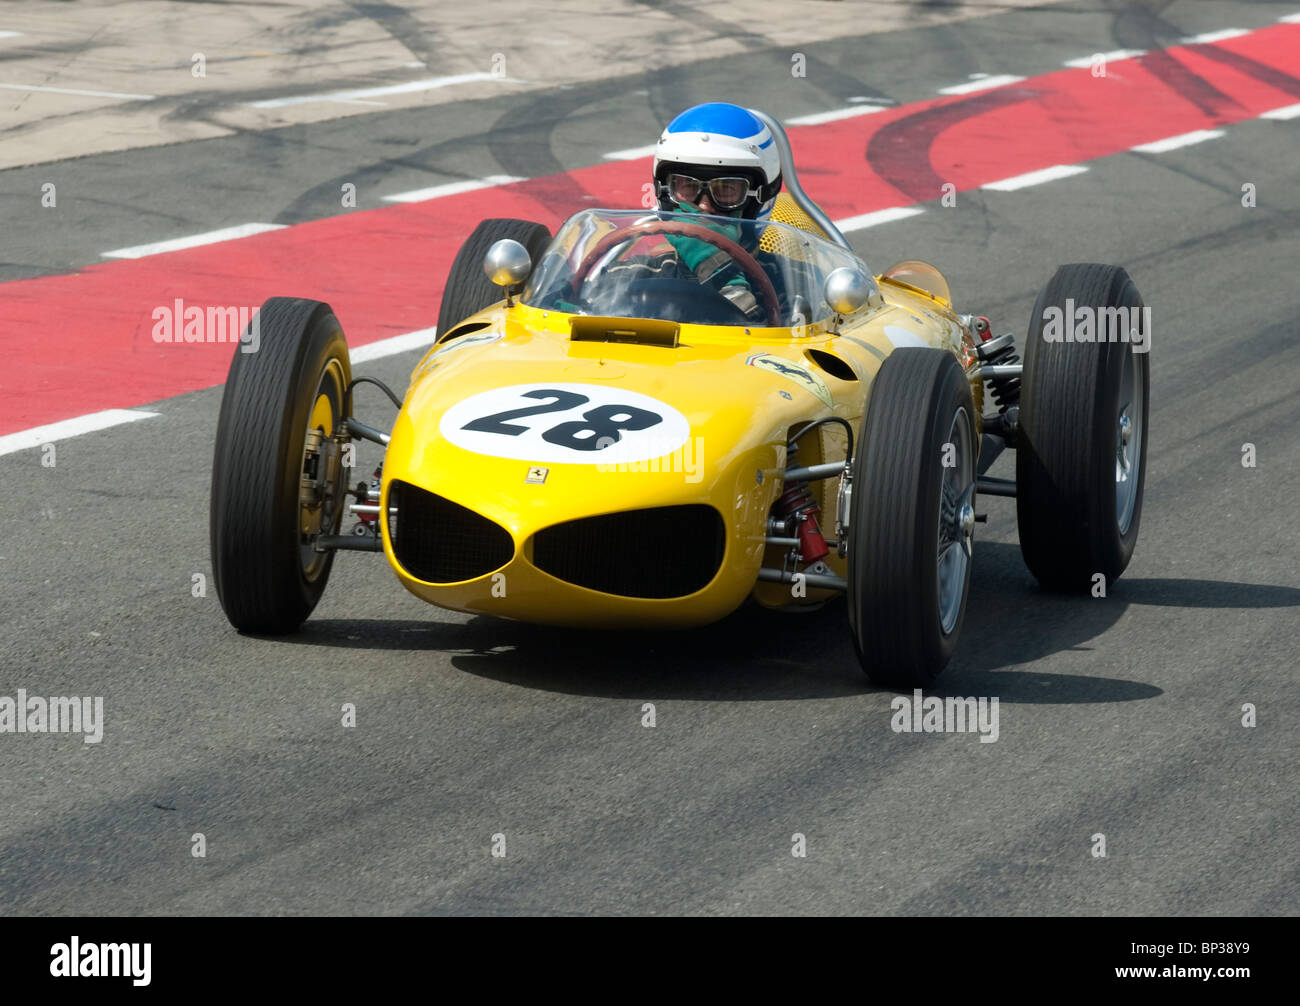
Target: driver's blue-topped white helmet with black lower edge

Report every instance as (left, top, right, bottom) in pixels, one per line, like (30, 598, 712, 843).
(654, 101, 781, 220)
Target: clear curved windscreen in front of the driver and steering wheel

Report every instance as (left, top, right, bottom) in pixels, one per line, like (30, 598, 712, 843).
(521, 209, 871, 328)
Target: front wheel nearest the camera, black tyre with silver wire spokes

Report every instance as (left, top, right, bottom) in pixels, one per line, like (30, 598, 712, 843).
(848, 347, 979, 688)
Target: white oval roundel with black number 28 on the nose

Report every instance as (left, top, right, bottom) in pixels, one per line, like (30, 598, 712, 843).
(438, 383, 690, 464)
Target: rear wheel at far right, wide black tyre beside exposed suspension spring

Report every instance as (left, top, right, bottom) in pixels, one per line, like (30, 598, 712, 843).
(1015, 263, 1151, 593)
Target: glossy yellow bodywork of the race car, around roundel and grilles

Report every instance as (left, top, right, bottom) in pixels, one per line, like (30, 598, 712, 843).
(381, 252, 980, 626)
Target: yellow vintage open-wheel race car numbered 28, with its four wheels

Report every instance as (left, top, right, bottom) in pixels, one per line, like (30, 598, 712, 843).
(211, 117, 1149, 688)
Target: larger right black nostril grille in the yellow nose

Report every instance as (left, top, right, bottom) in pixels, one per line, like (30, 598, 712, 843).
(533, 503, 725, 598)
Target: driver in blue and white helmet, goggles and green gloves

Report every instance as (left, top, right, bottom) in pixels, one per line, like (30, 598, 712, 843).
(642, 101, 781, 321)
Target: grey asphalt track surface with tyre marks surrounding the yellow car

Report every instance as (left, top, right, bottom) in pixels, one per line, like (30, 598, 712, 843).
(0, 3, 1300, 915)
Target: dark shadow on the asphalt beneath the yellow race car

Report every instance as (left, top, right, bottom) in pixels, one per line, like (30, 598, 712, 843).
(269, 542, 1300, 704)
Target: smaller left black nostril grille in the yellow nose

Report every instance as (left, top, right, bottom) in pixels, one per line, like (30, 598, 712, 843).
(389, 480, 515, 584)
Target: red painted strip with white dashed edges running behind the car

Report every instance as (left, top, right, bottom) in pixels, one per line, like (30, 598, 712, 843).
(0, 18, 1300, 452)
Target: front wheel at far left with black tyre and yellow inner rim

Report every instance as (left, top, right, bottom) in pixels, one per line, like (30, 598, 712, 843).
(209, 296, 352, 634)
